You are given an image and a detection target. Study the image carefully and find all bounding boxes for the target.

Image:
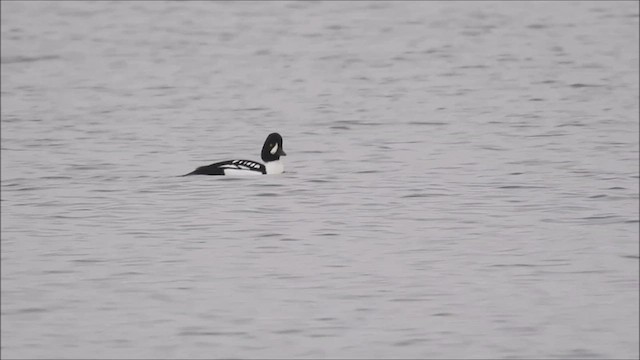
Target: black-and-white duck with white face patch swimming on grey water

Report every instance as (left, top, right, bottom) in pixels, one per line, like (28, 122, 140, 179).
(182, 132, 287, 176)
